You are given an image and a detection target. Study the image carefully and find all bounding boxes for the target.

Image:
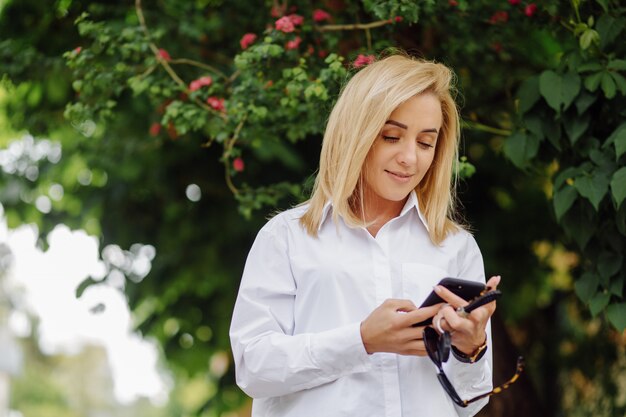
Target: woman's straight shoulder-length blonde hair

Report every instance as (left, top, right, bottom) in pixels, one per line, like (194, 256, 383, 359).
(300, 54, 460, 244)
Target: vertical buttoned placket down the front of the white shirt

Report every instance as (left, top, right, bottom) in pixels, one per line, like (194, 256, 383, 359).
(369, 230, 402, 417)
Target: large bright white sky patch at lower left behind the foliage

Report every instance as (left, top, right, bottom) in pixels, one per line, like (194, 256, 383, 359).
(0, 210, 169, 404)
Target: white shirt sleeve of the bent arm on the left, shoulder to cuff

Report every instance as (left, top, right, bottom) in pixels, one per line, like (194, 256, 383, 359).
(230, 218, 371, 398)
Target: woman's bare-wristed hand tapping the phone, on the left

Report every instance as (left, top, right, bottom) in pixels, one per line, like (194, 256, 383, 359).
(361, 299, 443, 356)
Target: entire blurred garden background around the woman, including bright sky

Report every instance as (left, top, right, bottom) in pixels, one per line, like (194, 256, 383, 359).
(0, 0, 626, 417)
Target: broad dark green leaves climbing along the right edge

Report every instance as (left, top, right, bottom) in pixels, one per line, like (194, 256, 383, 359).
(505, 3, 626, 331)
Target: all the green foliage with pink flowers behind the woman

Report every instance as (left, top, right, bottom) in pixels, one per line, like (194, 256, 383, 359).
(0, 0, 626, 415)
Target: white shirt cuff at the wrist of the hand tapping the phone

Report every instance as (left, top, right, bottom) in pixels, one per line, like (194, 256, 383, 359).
(310, 322, 372, 376)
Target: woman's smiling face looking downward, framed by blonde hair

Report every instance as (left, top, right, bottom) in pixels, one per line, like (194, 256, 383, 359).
(363, 93, 443, 209)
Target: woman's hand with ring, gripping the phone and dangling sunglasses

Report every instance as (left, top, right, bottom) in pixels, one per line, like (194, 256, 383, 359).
(433, 276, 500, 355)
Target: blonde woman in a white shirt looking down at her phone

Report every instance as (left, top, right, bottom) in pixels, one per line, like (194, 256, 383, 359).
(231, 55, 499, 417)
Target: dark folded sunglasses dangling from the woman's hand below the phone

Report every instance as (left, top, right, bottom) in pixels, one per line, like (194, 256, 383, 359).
(424, 327, 524, 407)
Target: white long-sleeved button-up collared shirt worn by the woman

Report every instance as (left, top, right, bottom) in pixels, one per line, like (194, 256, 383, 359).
(230, 193, 492, 417)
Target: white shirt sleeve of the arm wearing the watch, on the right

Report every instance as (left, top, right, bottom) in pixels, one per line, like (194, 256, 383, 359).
(444, 233, 493, 417)
